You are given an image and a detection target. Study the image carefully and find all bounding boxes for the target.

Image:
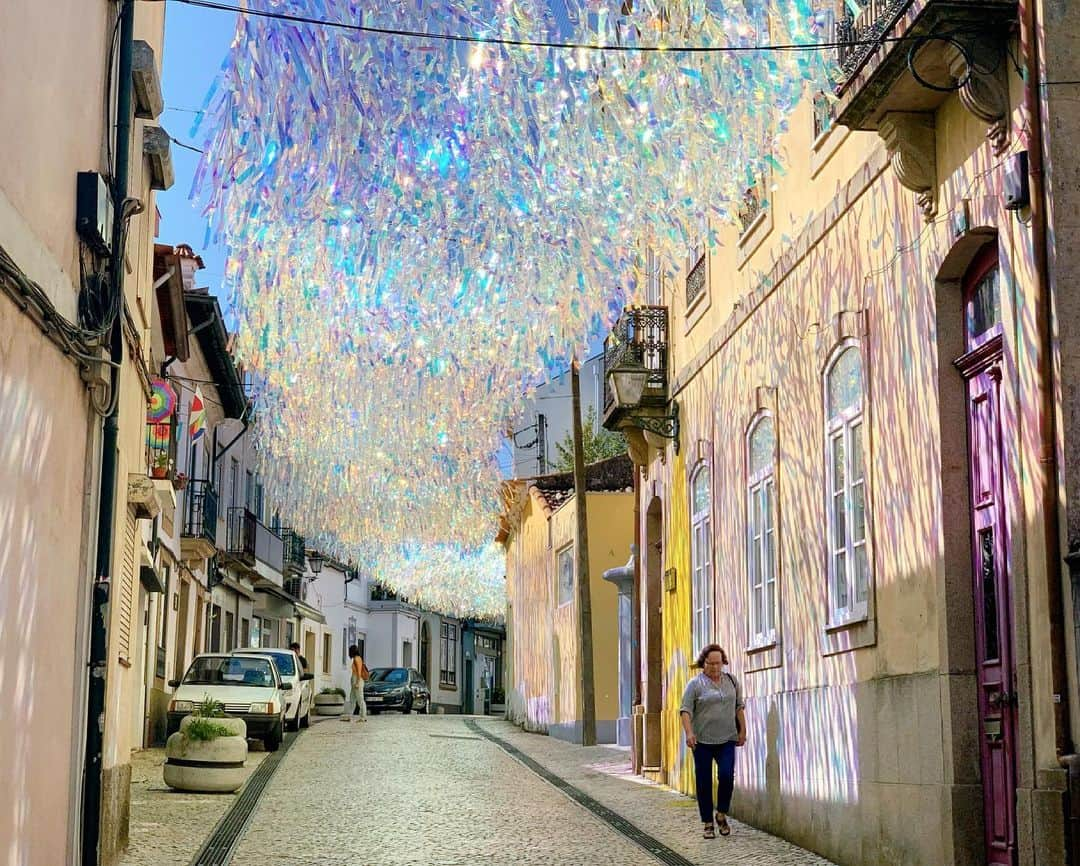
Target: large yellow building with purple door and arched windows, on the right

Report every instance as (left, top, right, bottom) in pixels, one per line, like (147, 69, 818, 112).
(606, 3, 1077, 866)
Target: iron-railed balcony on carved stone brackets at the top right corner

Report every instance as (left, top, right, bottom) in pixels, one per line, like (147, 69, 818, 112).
(834, 0, 1017, 219)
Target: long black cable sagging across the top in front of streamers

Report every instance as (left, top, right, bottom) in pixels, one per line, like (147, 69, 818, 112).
(149, 0, 904, 54)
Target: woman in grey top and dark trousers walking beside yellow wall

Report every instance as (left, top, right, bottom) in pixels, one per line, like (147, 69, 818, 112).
(679, 644, 746, 839)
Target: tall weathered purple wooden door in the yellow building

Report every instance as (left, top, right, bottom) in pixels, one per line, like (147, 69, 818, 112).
(957, 249, 1016, 866)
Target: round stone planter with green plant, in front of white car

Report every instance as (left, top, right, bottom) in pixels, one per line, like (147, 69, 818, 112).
(164, 698, 247, 794)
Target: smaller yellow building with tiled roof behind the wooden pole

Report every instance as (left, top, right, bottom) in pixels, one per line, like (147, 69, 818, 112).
(497, 457, 634, 743)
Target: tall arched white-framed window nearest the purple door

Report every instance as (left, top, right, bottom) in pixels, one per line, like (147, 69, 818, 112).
(825, 341, 870, 624)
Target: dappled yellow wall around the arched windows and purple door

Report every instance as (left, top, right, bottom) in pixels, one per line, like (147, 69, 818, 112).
(643, 62, 1059, 864)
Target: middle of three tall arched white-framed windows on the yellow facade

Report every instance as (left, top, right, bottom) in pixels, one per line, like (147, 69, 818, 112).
(746, 415, 777, 647)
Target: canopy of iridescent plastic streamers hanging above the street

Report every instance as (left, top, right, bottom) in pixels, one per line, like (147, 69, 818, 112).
(192, 0, 829, 612)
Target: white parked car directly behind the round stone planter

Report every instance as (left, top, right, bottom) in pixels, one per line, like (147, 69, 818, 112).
(166, 653, 293, 752)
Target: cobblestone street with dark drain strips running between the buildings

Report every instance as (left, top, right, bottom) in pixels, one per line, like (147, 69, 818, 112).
(122, 715, 829, 866)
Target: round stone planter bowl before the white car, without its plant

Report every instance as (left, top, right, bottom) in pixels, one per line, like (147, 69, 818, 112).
(164, 716, 247, 794)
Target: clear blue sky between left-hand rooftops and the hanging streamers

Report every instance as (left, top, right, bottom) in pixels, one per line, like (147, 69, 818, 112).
(158, 3, 237, 293)
